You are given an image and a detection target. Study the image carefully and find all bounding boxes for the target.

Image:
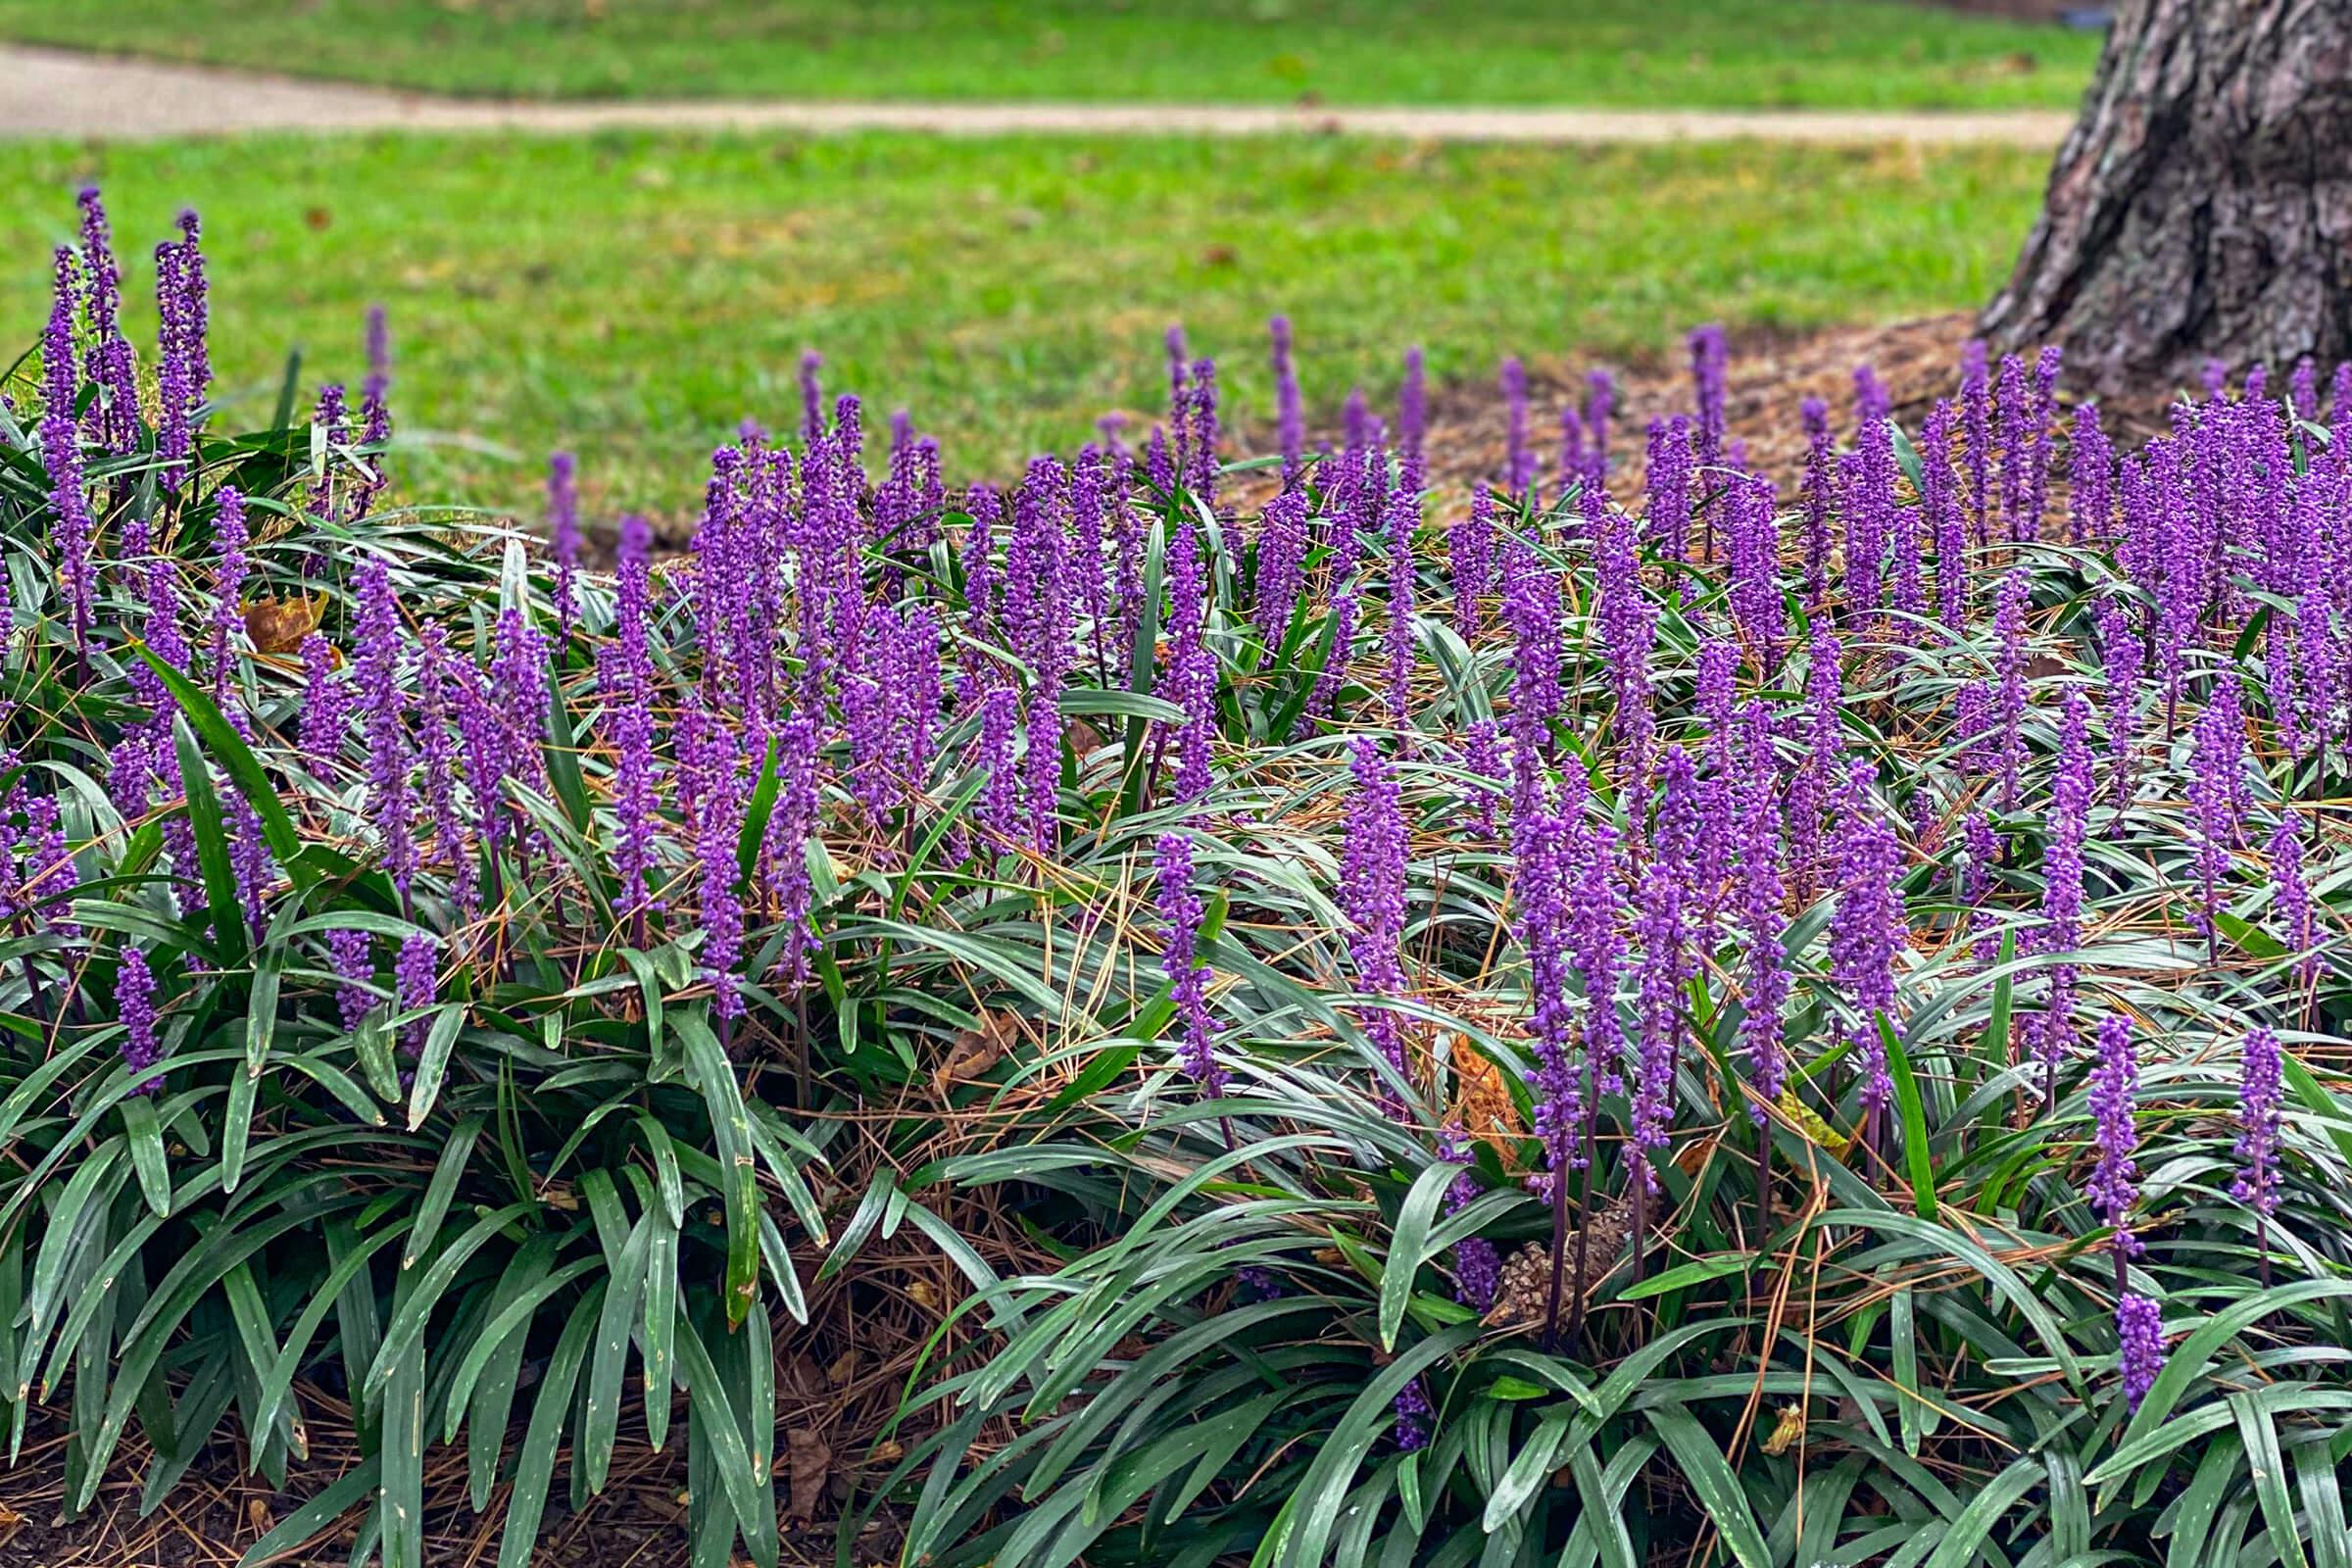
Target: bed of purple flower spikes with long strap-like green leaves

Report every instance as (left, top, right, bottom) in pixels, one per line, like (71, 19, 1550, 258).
(0, 190, 2352, 1568)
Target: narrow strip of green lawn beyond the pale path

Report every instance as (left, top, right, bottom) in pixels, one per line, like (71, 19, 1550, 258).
(0, 0, 2098, 108)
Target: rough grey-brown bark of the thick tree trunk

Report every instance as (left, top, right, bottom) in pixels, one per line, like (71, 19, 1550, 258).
(1981, 0, 2352, 393)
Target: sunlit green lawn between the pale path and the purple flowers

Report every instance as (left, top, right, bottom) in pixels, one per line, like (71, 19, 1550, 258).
(0, 134, 2046, 517)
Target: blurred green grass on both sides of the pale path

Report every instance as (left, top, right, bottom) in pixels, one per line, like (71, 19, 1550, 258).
(0, 0, 2095, 517)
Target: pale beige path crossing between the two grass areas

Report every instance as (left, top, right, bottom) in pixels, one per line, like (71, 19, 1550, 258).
(0, 45, 2072, 148)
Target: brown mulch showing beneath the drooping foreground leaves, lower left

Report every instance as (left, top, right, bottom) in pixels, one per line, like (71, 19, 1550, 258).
(0, 1091, 1060, 1568)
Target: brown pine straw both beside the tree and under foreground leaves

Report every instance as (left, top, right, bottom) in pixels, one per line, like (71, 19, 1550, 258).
(0, 315, 2159, 1568)
